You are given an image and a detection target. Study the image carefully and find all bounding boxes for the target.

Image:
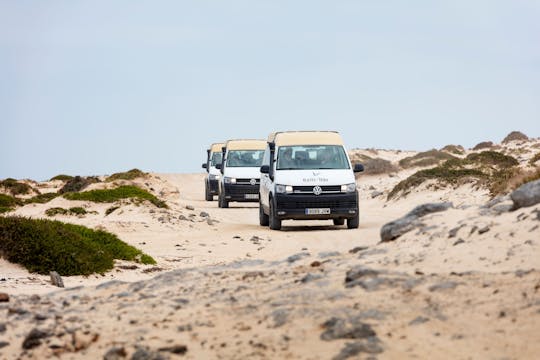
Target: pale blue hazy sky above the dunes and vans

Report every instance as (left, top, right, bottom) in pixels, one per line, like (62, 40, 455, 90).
(0, 0, 540, 180)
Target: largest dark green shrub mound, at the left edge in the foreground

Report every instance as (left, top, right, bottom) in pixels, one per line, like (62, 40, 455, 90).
(0, 217, 156, 276)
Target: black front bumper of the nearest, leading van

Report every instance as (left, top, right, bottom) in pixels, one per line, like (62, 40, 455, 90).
(274, 191, 358, 220)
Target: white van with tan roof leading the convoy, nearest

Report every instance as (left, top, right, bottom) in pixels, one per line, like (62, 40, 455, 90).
(259, 131, 364, 230)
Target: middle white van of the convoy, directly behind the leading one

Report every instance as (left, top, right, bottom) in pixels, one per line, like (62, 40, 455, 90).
(217, 140, 266, 208)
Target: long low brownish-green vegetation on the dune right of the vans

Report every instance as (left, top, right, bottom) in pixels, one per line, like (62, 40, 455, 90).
(388, 151, 520, 199)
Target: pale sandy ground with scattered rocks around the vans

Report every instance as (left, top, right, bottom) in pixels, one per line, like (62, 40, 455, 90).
(0, 139, 540, 359)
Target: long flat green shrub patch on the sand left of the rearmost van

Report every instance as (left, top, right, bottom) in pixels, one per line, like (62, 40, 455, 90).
(64, 185, 167, 208)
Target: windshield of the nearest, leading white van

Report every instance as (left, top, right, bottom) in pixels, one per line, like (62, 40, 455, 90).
(276, 145, 350, 170)
